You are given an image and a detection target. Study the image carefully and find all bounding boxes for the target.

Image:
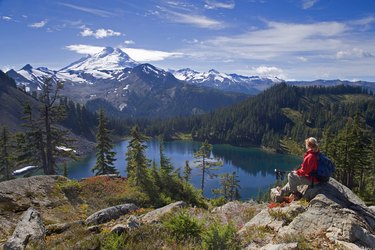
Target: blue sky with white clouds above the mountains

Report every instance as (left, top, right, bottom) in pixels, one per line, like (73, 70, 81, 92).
(0, 0, 375, 81)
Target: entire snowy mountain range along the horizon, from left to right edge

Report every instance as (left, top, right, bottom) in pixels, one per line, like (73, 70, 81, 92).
(7, 47, 375, 118)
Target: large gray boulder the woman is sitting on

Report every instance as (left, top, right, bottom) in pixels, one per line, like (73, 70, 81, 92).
(279, 178, 375, 248)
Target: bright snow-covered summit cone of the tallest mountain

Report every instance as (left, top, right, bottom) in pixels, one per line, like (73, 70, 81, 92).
(59, 47, 139, 72)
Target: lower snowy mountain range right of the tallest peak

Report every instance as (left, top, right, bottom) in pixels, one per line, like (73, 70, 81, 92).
(171, 68, 280, 94)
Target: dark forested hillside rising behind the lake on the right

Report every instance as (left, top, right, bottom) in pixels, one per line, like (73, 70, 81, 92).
(148, 83, 375, 150)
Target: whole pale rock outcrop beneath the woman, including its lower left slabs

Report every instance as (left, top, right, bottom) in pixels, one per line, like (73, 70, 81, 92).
(239, 178, 375, 249)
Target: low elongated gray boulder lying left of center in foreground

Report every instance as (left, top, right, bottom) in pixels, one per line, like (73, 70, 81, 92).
(85, 203, 138, 225)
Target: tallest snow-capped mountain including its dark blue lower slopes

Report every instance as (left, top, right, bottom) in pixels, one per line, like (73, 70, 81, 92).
(7, 47, 246, 117)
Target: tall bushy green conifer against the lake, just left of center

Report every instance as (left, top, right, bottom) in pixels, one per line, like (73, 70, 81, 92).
(126, 127, 150, 187)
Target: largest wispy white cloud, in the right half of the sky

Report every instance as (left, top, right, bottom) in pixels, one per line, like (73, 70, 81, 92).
(185, 19, 348, 61)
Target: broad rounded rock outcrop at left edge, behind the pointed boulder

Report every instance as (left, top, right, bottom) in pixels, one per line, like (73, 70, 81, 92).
(0, 175, 71, 242)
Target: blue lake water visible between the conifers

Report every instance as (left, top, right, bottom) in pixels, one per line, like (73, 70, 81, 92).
(68, 140, 302, 200)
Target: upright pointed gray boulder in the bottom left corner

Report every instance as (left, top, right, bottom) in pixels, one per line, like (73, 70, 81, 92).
(4, 208, 45, 250)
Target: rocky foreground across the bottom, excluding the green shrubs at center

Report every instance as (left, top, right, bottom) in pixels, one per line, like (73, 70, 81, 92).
(0, 176, 375, 249)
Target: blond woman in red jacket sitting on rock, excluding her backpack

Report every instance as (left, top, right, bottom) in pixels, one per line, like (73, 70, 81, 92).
(276, 137, 319, 201)
